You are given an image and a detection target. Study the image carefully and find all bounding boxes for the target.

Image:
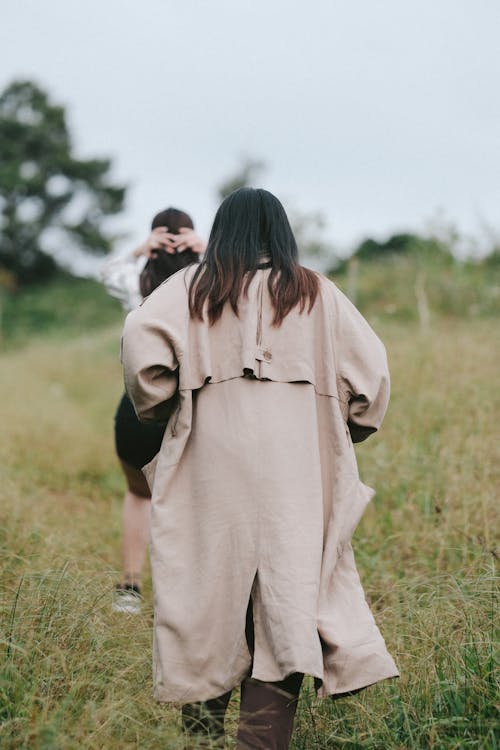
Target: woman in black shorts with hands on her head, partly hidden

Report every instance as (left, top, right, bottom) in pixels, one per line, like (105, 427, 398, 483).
(102, 208, 206, 614)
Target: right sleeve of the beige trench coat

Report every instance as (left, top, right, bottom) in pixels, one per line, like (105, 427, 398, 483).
(334, 287, 390, 443)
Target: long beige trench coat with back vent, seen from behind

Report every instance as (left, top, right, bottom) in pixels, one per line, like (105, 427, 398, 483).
(122, 267, 398, 702)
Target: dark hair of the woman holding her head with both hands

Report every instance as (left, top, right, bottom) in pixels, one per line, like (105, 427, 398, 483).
(139, 208, 199, 297)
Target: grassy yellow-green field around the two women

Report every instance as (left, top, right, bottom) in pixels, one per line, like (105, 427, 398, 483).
(0, 319, 500, 750)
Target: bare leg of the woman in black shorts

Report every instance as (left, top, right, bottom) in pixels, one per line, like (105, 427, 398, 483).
(121, 461, 151, 587)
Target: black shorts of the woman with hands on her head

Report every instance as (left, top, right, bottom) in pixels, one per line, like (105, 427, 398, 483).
(115, 393, 165, 469)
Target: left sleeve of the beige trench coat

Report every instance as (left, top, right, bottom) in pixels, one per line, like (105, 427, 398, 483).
(121, 306, 179, 423)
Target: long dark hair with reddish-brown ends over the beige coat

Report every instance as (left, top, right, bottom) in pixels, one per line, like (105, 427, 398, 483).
(189, 188, 319, 326)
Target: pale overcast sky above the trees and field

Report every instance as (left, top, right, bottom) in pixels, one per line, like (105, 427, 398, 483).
(0, 0, 500, 268)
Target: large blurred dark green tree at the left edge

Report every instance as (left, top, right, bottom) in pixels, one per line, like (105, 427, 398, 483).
(0, 81, 125, 284)
